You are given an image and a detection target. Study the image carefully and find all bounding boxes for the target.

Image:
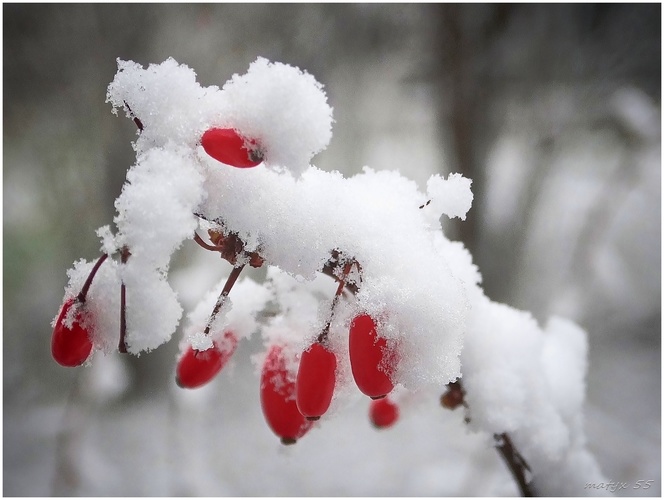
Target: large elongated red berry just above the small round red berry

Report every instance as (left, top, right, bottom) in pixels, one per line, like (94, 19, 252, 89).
(348, 314, 396, 399)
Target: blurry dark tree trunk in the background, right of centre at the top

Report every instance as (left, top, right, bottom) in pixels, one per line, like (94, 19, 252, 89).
(432, 4, 511, 258)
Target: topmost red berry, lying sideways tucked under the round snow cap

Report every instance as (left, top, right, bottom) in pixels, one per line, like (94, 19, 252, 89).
(201, 128, 263, 168)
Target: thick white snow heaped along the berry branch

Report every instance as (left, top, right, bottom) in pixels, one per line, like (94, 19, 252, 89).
(58, 58, 601, 494)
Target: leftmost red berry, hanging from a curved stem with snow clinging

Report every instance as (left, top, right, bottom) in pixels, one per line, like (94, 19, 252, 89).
(51, 298, 92, 366)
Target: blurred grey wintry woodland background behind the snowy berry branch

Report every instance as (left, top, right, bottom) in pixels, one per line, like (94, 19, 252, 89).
(3, 4, 661, 496)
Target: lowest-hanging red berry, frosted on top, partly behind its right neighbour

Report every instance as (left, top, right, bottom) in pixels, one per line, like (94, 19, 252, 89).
(260, 345, 312, 444)
